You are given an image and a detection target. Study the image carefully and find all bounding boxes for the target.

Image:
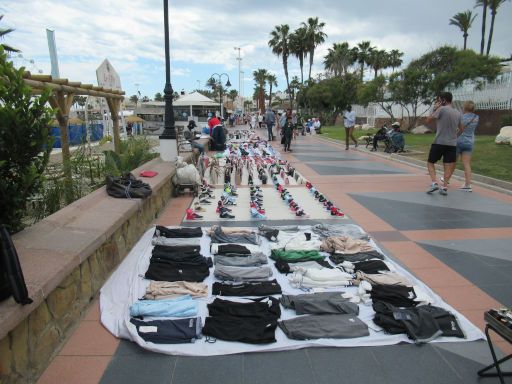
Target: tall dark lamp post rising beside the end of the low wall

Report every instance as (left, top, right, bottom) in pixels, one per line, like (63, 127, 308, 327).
(159, 0, 178, 161)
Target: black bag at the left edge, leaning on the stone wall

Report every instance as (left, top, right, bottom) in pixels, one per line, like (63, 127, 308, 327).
(0, 225, 32, 305)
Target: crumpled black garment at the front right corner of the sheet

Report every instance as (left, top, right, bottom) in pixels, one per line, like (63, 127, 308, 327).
(373, 301, 465, 343)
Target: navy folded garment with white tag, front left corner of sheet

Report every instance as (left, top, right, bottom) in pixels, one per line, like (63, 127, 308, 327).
(130, 317, 202, 344)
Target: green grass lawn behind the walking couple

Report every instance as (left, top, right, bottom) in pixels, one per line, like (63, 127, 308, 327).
(322, 126, 512, 181)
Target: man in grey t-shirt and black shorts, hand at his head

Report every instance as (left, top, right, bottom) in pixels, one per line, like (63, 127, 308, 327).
(427, 92, 463, 196)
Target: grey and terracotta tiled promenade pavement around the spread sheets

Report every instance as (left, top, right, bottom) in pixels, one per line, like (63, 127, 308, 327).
(39, 126, 512, 384)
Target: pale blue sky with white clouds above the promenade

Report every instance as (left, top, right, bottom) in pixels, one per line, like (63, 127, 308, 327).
(0, 0, 512, 98)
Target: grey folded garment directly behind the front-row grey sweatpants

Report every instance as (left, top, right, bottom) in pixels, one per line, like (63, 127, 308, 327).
(280, 292, 359, 315)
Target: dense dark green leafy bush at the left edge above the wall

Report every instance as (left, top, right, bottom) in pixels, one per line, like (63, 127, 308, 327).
(0, 47, 53, 233)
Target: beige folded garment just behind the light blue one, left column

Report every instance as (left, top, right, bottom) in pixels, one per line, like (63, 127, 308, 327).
(144, 281, 208, 300)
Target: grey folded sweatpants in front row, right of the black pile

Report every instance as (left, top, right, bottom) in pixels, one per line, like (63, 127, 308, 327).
(278, 315, 370, 340)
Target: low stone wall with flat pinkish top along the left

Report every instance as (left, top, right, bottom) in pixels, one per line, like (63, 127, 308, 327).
(0, 154, 188, 383)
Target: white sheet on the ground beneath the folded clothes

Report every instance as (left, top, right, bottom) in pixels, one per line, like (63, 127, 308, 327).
(100, 227, 484, 356)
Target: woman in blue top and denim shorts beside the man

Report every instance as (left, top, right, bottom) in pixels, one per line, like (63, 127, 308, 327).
(457, 101, 480, 192)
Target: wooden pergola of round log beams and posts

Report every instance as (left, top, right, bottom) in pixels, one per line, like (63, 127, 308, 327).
(23, 72, 124, 202)
